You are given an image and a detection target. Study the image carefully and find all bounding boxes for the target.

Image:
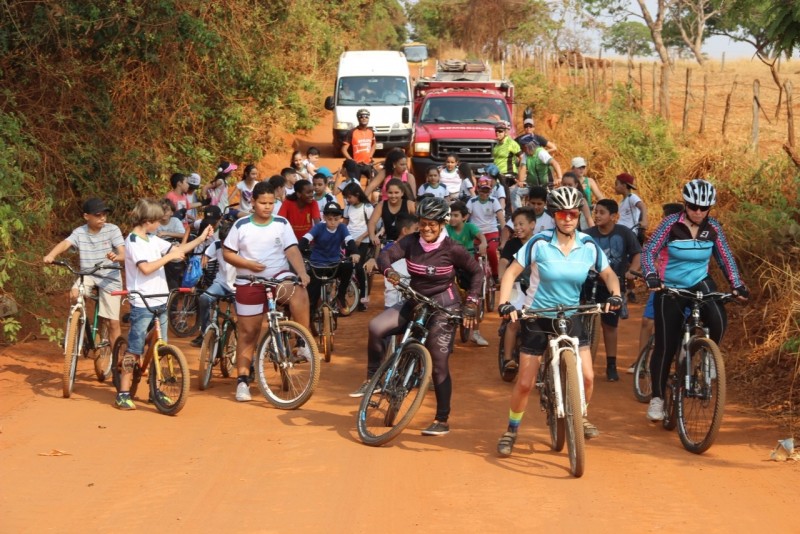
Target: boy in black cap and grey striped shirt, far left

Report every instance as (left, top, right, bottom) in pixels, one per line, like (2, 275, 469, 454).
(42, 198, 125, 343)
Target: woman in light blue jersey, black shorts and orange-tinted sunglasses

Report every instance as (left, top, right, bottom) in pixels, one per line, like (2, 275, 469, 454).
(497, 187, 622, 456)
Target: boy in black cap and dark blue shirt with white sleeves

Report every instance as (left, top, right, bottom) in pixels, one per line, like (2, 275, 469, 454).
(299, 202, 361, 310)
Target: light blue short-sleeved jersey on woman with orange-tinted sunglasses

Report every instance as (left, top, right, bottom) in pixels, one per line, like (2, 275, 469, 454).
(514, 230, 608, 317)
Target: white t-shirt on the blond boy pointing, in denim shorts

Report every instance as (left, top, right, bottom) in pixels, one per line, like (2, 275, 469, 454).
(125, 233, 172, 308)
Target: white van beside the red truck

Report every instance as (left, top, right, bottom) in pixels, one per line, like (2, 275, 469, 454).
(325, 50, 414, 153)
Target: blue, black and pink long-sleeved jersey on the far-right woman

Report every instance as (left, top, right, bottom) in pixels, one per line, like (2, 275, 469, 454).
(642, 212, 744, 289)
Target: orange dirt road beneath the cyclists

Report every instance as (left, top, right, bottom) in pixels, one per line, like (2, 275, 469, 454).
(0, 119, 800, 532)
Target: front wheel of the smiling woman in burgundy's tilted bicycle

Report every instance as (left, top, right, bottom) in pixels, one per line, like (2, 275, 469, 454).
(356, 343, 433, 447)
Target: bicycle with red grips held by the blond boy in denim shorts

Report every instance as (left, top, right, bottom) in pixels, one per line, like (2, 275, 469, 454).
(111, 287, 192, 415)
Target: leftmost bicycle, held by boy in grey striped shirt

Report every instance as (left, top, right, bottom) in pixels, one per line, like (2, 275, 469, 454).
(53, 260, 121, 399)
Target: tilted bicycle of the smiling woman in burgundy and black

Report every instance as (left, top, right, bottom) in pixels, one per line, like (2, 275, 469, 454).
(356, 280, 463, 447)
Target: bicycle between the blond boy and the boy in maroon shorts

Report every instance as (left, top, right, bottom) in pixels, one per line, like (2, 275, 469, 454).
(199, 295, 239, 391)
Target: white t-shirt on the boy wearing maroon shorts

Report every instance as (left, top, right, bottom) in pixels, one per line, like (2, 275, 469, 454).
(225, 215, 297, 278)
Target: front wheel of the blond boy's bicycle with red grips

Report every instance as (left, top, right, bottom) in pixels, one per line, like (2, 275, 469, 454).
(150, 345, 189, 415)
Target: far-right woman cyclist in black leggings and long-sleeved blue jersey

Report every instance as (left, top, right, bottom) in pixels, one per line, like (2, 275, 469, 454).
(642, 179, 750, 422)
